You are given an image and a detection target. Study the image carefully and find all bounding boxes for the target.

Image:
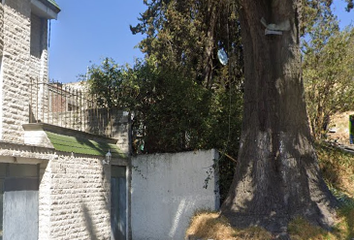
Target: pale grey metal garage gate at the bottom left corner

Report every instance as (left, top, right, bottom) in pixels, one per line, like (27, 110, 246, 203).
(0, 163, 39, 240)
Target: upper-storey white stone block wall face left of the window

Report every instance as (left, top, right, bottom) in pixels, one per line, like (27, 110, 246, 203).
(2, 0, 31, 142)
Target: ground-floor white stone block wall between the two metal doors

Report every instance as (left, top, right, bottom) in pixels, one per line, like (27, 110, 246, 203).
(39, 155, 111, 240)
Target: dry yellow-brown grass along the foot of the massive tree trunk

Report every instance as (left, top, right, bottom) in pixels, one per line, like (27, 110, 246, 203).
(186, 212, 354, 240)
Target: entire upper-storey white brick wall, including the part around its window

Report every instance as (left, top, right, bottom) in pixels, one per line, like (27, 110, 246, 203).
(0, 0, 48, 143)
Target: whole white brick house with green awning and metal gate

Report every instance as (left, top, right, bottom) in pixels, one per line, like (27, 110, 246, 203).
(0, 0, 129, 240)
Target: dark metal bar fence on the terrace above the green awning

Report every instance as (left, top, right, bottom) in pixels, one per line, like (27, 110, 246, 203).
(29, 80, 119, 137)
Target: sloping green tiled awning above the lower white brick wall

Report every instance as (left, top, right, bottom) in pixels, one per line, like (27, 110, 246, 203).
(45, 131, 126, 158)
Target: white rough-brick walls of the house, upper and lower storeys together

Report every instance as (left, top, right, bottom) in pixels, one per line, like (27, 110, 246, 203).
(0, 0, 115, 240)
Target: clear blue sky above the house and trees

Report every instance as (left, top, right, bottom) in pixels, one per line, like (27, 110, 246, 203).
(49, 0, 354, 82)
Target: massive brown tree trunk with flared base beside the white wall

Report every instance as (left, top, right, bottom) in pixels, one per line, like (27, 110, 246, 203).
(222, 0, 336, 232)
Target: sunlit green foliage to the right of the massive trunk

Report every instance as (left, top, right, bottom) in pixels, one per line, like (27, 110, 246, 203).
(302, 0, 354, 139)
